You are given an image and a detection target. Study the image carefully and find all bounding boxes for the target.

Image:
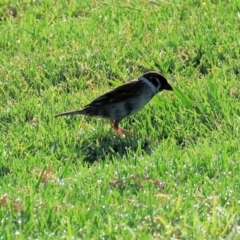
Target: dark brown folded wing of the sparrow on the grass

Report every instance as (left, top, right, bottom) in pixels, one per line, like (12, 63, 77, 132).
(85, 80, 142, 107)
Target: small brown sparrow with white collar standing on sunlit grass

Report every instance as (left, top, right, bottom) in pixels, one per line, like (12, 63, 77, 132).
(54, 71, 173, 137)
